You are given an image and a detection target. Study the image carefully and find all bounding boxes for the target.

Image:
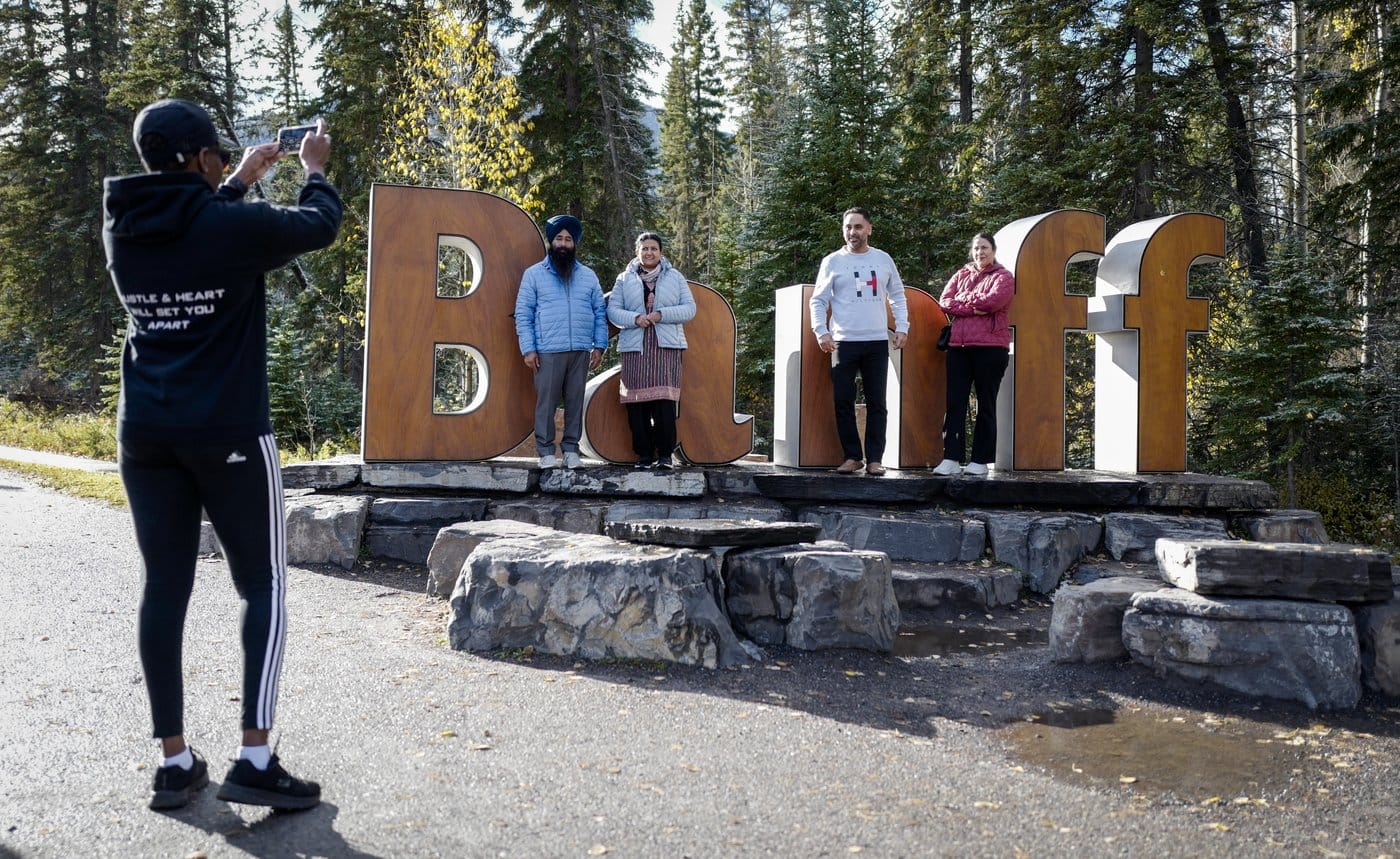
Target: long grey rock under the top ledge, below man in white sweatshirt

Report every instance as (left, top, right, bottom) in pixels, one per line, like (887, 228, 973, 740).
(799, 506, 987, 564)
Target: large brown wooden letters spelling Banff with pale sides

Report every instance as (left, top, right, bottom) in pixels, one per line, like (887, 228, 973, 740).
(361, 185, 1225, 473)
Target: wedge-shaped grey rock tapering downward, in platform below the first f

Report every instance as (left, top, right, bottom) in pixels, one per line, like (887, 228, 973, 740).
(972, 511, 1103, 593)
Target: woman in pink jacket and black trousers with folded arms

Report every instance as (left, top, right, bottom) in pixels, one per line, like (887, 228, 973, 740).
(934, 232, 1016, 476)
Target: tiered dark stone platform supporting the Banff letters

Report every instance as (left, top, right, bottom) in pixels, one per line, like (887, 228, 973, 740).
(283, 456, 1288, 601)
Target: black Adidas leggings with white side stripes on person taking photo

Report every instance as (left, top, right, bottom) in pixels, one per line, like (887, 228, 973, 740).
(118, 434, 287, 737)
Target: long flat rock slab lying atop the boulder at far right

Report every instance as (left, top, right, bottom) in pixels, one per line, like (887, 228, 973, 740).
(1156, 539, 1392, 603)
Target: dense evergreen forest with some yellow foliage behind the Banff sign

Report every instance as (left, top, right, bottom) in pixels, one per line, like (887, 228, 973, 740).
(0, 0, 1400, 546)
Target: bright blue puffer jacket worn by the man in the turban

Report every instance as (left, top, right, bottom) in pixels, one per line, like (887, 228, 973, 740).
(515, 256, 608, 355)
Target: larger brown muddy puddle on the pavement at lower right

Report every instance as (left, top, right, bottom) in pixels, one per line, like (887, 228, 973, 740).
(1007, 705, 1306, 803)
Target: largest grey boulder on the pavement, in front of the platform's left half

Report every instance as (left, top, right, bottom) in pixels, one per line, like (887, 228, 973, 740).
(448, 533, 762, 667)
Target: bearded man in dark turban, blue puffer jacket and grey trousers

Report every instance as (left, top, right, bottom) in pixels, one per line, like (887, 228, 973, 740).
(515, 215, 608, 469)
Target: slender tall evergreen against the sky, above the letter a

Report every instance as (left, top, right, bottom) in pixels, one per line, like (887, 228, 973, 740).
(661, 0, 731, 281)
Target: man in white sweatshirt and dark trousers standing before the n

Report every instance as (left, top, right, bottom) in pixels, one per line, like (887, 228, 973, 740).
(809, 207, 909, 477)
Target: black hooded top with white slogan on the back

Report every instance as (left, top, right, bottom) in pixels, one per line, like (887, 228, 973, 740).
(102, 172, 342, 445)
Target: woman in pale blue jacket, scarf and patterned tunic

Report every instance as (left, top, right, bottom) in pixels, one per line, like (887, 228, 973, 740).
(608, 232, 696, 469)
